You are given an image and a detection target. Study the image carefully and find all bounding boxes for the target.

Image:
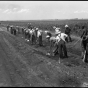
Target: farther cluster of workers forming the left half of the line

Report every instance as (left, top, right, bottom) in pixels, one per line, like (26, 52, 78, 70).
(7, 25, 43, 46)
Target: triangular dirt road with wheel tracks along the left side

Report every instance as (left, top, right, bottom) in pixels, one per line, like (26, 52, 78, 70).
(0, 28, 53, 86)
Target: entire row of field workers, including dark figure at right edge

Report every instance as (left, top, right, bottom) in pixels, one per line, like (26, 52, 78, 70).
(7, 23, 88, 62)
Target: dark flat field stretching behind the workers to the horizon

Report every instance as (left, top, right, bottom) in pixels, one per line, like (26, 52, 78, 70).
(0, 19, 88, 35)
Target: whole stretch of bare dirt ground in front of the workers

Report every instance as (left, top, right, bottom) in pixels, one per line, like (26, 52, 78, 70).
(0, 28, 88, 87)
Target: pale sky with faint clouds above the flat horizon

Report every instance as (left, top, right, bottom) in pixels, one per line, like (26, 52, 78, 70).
(0, 1, 88, 20)
